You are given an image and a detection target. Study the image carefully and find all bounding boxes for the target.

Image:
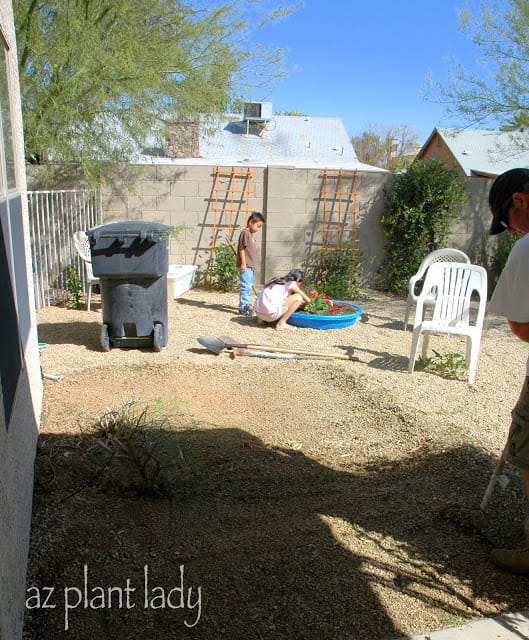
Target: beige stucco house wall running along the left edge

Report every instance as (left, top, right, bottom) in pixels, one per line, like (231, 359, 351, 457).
(0, 0, 42, 640)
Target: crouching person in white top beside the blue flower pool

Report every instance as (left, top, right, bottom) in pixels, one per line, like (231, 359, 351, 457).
(255, 269, 310, 331)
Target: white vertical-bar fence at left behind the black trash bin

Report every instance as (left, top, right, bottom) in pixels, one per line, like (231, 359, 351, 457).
(28, 190, 102, 309)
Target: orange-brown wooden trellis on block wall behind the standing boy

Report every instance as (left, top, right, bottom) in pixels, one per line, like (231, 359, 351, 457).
(206, 167, 253, 256)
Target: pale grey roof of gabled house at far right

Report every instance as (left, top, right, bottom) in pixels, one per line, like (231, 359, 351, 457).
(423, 129, 529, 177)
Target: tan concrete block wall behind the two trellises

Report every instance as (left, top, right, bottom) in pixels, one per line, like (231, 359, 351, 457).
(30, 162, 497, 286)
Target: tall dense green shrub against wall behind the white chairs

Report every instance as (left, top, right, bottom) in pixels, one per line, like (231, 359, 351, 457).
(379, 159, 466, 293)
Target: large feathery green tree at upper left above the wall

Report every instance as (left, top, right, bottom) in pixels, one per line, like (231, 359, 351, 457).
(13, 0, 290, 181)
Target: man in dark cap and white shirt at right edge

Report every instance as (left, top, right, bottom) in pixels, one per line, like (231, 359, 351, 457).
(488, 169, 529, 576)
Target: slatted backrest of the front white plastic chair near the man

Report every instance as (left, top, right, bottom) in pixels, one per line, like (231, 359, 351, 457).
(415, 262, 487, 328)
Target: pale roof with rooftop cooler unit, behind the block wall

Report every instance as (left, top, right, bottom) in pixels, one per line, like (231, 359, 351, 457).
(139, 114, 384, 171)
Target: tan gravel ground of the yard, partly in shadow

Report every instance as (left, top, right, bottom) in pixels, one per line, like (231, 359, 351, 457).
(26, 289, 528, 640)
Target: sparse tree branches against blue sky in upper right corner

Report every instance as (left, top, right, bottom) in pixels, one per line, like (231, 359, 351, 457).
(430, 0, 529, 129)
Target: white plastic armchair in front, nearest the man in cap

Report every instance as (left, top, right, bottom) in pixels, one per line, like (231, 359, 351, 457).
(408, 262, 487, 384)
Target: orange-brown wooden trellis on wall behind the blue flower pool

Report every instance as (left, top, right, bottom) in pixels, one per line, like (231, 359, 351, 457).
(319, 169, 359, 251)
